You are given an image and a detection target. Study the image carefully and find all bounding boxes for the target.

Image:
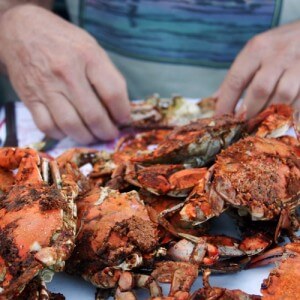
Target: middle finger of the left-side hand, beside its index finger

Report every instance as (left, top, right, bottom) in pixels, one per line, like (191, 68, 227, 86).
(70, 78, 119, 140)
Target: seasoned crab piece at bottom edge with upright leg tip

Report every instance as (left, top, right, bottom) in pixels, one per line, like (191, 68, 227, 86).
(189, 269, 261, 300)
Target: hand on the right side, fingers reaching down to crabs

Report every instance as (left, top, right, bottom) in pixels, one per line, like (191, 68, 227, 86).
(216, 22, 300, 118)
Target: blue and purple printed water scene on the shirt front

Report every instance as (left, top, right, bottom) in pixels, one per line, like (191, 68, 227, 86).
(80, 0, 282, 68)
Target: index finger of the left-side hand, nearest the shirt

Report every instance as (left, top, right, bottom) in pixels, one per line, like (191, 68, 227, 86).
(87, 53, 130, 124)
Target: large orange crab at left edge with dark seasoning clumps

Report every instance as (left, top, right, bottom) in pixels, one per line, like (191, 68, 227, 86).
(0, 148, 78, 299)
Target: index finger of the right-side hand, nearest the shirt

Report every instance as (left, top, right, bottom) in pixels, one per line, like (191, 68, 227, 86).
(216, 46, 260, 115)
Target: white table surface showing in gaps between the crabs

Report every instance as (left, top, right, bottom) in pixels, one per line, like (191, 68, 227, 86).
(0, 103, 292, 300)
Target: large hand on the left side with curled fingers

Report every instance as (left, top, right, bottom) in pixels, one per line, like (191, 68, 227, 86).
(0, 5, 130, 144)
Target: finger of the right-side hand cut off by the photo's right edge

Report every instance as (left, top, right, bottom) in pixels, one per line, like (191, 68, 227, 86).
(270, 66, 300, 104)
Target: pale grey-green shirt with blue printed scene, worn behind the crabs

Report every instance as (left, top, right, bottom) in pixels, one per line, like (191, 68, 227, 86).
(67, 0, 300, 99)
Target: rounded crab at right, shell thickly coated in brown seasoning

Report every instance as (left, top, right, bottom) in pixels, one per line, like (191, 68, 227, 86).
(180, 137, 300, 240)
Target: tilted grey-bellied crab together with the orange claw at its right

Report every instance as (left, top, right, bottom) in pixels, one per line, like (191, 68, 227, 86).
(132, 104, 293, 167)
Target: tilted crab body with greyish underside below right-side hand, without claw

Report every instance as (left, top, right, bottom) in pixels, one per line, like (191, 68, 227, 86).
(132, 115, 243, 167)
